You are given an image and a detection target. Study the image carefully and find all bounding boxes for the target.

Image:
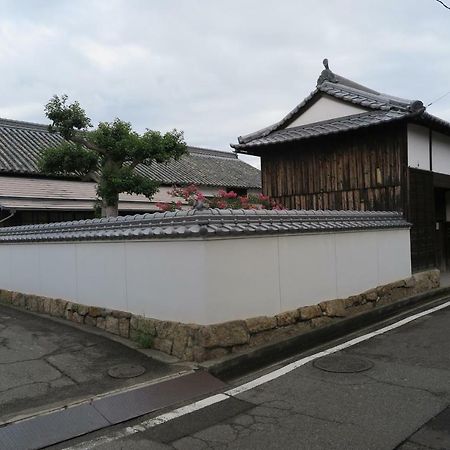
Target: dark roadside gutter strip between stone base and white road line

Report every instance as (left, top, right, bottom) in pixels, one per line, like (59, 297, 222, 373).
(198, 287, 450, 379)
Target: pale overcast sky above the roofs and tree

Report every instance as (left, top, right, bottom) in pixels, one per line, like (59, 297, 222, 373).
(0, 0, 450, 169)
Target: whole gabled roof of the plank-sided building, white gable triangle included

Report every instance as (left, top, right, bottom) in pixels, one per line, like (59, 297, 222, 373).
(231, 61, 450, 155)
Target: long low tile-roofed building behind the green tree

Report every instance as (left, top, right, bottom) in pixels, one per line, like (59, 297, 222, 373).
(0, 119, 261, 226)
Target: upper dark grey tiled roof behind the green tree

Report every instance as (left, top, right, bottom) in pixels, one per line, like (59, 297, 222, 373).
(0, 119, 261, 188)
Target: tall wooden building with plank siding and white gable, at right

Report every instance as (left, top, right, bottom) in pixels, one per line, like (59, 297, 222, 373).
(232, 60, 450, 271)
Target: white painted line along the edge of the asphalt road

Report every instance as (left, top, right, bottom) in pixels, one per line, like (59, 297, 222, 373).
(64, 301, 450, 450)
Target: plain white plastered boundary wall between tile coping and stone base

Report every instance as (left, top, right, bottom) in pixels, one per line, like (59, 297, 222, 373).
(0, 229, 411, 324)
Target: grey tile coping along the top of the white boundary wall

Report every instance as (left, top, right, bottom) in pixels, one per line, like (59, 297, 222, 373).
(0, 209, 410, 243)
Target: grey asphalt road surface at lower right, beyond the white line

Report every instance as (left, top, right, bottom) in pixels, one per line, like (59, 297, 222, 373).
(58, 298, 450, 450)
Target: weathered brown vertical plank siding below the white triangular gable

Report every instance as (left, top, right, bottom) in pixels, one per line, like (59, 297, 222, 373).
(261, 126, 406, 211)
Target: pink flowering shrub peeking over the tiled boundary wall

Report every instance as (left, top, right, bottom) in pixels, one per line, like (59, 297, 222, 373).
(156, 184, 284, 211)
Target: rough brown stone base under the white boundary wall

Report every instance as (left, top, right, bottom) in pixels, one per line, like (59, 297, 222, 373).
(0, 270, 439, 362)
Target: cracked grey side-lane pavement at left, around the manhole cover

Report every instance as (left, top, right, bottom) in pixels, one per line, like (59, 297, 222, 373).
(0, 306, 182, 423)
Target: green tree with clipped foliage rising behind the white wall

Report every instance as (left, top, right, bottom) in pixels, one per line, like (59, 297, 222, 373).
(39, 95, 186, 217)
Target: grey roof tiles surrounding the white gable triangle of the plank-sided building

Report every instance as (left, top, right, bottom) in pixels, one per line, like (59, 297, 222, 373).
(232, 62, 450, 153)
